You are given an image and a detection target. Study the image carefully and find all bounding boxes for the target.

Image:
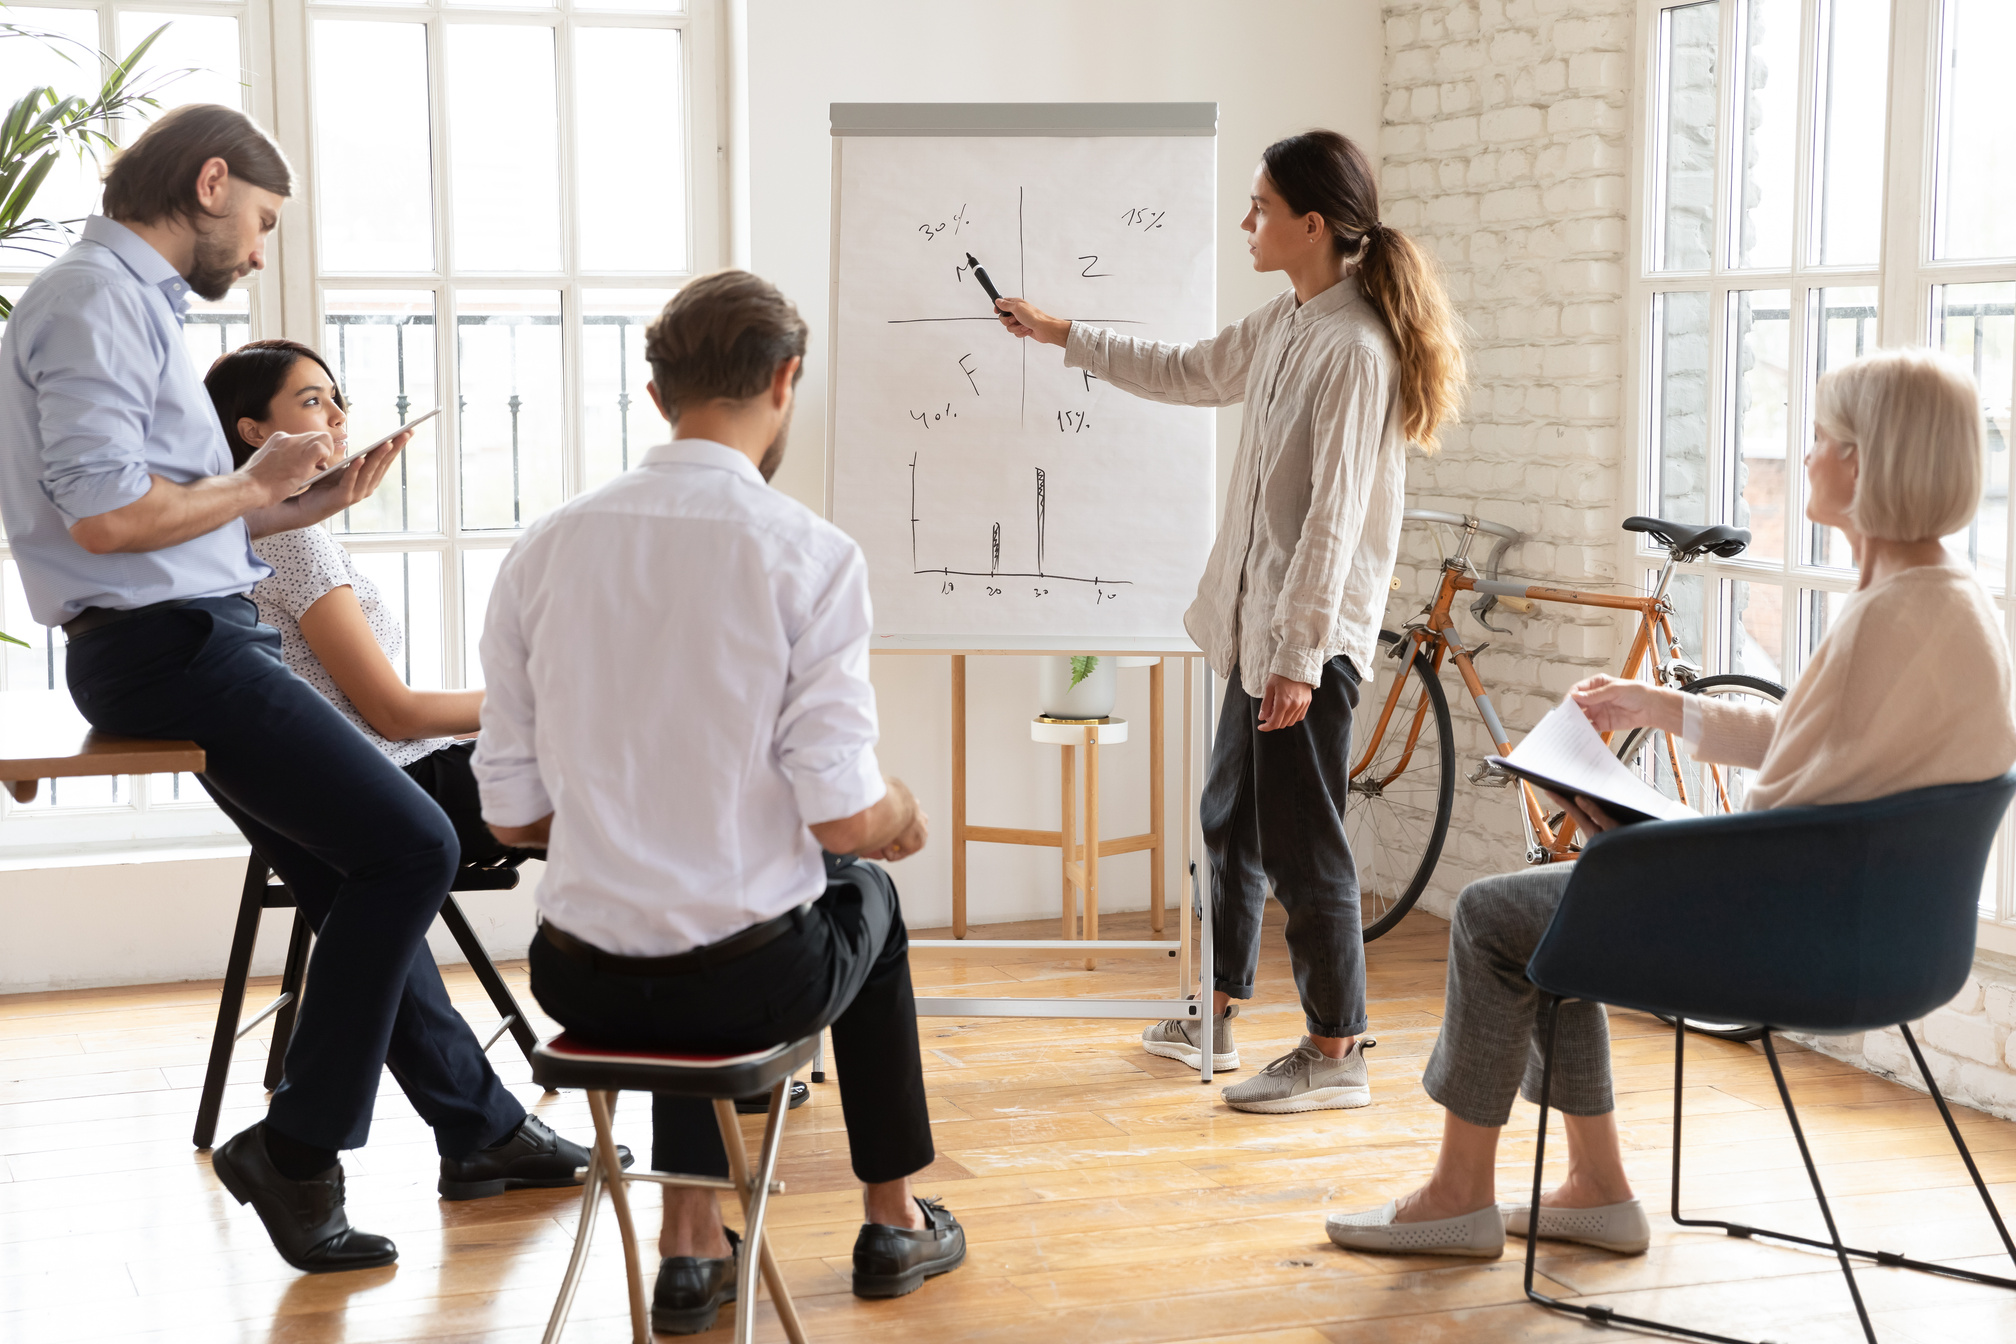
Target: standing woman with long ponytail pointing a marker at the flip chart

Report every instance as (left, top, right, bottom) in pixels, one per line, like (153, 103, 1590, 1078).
(1000, 131, 1464, 1112)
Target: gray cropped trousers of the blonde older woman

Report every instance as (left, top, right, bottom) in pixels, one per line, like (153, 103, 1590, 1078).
(1421, 864, 1617, 1128)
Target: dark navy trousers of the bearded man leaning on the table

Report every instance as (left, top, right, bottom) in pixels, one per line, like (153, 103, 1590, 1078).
(69, 596, 524, 1159)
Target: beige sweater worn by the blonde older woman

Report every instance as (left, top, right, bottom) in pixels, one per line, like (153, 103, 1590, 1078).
(1687, 564, 2016, 810)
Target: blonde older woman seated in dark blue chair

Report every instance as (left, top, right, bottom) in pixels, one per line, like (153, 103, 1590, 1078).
(1329, 351, 2016, 1257)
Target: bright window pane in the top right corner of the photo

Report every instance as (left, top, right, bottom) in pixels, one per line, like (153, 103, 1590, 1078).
(1933, 0, 2016, 258)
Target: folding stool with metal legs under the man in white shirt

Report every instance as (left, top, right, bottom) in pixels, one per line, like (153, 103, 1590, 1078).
(532, 1032, 818, 1344)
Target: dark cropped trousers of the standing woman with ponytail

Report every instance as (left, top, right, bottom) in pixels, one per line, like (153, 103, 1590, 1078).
(1202, 655, 1367, 1036)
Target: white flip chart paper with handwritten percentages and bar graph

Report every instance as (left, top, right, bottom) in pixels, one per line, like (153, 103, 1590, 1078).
(831, 135, 1218, 641)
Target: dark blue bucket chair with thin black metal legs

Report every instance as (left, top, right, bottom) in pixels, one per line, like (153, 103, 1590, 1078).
(1526, 772, 2016, 1344)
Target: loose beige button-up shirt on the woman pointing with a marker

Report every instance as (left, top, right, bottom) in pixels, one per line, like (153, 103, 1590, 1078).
(1064, 276, 1407, 697)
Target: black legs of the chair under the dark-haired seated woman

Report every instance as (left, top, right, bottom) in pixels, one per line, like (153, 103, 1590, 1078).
(196, 850, 538, 1149)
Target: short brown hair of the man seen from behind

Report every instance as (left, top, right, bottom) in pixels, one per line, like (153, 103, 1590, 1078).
(643, 270, 808, 421)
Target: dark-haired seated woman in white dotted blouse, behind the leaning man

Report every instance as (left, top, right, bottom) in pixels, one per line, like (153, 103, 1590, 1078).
(204, 341, 510, 862)
